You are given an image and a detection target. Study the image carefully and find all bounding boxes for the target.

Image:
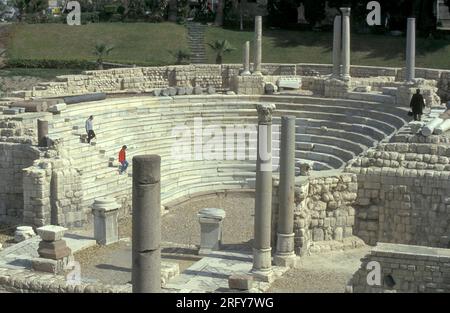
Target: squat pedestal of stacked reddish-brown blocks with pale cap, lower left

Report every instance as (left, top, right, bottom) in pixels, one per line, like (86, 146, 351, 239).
(32, 225, 73, 274)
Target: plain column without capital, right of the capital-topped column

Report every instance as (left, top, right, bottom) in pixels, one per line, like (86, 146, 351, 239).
(274, 116, 296, 267)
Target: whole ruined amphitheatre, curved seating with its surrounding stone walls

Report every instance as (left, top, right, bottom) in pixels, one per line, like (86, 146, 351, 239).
(0, 15, 450, 292)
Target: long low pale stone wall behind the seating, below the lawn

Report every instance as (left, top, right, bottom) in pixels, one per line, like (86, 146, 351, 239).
(16, 63, 450, 101)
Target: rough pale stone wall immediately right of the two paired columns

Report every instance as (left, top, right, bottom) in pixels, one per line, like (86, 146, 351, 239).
(272, 173, 357, 255)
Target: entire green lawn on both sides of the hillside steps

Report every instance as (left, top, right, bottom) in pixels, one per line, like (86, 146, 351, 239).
(7, 23, 450, 69)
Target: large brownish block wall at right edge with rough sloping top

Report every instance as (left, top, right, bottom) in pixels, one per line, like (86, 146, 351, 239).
(347, 143, 450, 248)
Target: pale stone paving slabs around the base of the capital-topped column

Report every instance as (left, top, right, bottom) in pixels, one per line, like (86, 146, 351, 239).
(165, 251, 288, 293)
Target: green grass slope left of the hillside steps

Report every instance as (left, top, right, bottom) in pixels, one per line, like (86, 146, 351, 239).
(7, 23, 188, 65)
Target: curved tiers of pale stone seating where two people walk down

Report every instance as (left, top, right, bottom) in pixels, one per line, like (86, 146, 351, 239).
(45, 95, 406, 208)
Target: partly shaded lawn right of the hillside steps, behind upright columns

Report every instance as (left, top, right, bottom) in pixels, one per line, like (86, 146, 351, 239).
(206, 27, 450, 69)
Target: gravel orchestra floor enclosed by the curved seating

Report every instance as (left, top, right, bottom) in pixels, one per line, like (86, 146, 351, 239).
(75, 193, 254, 284)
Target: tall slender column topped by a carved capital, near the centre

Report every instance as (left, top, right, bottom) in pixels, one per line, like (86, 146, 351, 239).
(253, 104, 275, 281)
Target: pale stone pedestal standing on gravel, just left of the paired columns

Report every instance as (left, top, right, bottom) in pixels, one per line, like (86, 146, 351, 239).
(197, 208, 225, 255)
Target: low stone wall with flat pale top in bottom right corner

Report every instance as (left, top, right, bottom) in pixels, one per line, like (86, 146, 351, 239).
(349, 243, 450, 293)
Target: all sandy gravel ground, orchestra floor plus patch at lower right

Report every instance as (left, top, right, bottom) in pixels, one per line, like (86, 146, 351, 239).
(75, 194, 369, 293)
